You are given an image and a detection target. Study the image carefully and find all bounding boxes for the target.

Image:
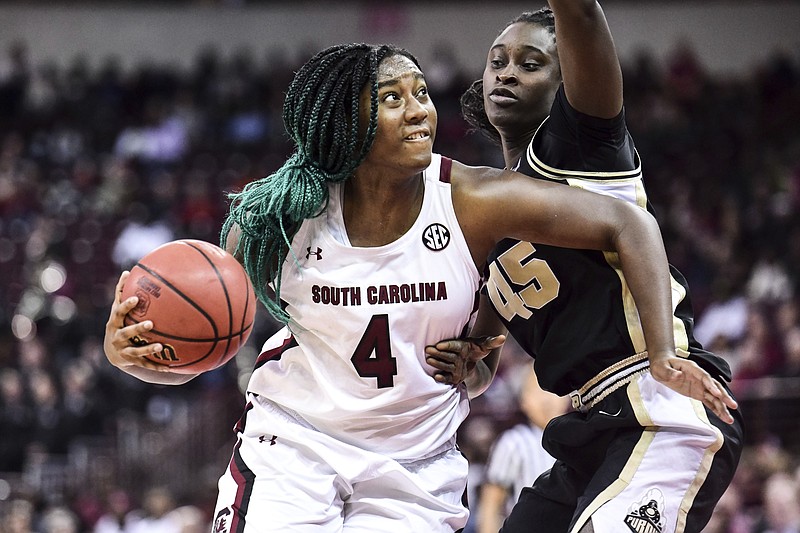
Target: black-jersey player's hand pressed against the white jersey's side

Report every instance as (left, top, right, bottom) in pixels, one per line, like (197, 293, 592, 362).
(425, 335, 506, 385)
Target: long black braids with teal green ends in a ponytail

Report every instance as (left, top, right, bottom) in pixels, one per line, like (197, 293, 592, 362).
(220, 43, 419, 323)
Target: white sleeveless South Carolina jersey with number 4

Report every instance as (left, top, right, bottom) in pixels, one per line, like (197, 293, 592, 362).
(248, 154, 480, 460)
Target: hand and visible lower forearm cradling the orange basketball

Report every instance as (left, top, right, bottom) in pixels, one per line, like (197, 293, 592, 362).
(103, 271, 195, 385)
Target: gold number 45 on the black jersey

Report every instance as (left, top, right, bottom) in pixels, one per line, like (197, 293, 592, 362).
(486, 242, 561, 322)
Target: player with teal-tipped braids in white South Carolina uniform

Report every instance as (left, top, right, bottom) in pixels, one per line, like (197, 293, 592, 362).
(105, 44, 736, 533)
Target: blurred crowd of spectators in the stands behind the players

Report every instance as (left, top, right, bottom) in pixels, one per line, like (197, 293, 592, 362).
(0, 32, 800, 533)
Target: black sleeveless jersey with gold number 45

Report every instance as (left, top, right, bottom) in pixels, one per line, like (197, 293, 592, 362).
(485, 86, 730, 395)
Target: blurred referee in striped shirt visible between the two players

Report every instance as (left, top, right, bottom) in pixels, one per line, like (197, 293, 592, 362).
(477, 364, 569, 533)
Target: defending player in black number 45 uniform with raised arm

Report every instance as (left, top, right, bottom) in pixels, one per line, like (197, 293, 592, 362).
(428, 0, 743, 533)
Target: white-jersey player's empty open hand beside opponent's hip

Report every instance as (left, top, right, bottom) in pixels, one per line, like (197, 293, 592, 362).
(650, 355, 738, 424)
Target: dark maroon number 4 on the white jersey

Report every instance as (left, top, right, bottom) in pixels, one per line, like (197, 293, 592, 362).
(350, 315, 397, 389)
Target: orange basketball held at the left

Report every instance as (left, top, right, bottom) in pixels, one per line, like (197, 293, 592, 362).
(122, 239, 257, 374)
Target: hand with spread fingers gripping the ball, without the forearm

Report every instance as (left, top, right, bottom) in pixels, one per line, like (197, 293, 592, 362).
(103, 271, 169, 372)
